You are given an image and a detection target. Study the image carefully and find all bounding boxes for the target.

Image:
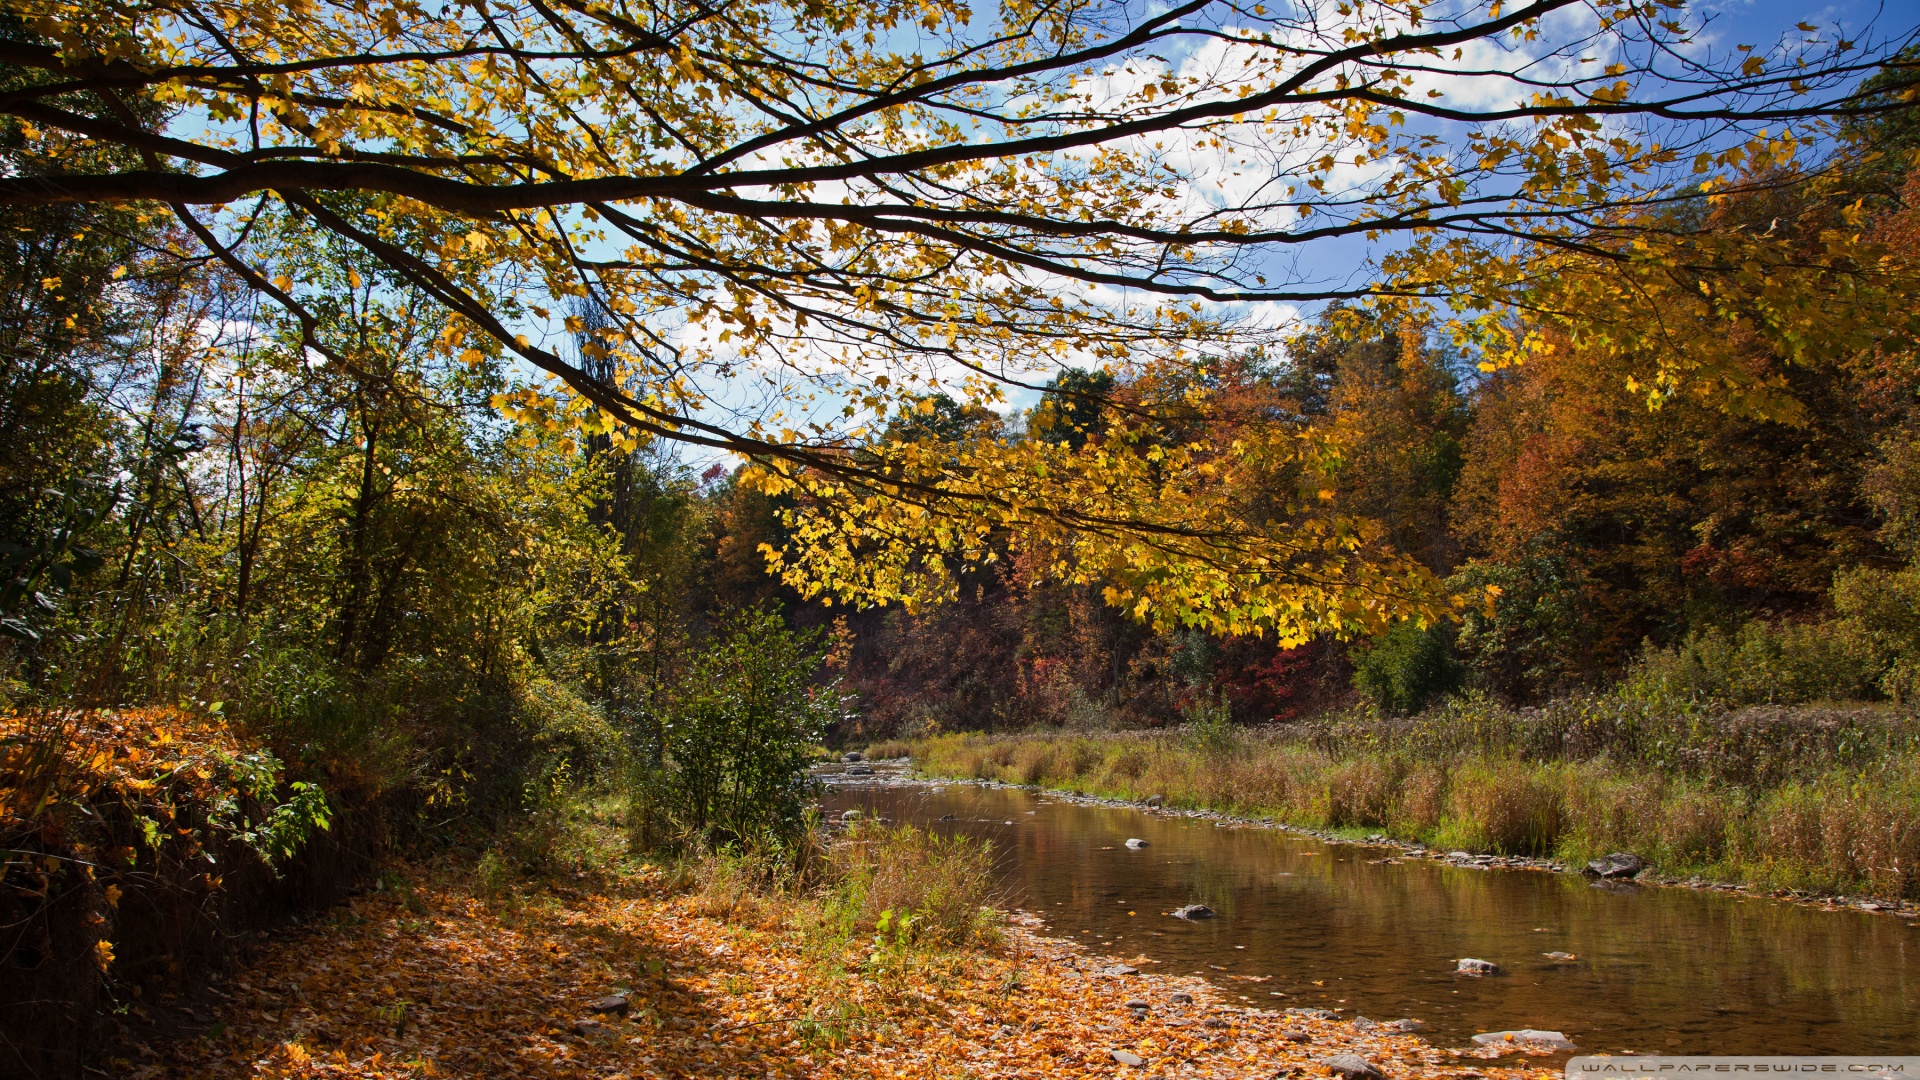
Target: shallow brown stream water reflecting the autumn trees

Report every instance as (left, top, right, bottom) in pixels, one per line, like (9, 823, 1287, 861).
(824, 774, 1920, 1053)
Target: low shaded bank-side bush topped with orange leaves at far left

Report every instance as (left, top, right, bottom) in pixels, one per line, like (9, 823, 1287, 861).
(0, 709, 336, 1076)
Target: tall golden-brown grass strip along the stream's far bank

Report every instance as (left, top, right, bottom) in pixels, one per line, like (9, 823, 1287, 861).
(914, 700, 1920, 899)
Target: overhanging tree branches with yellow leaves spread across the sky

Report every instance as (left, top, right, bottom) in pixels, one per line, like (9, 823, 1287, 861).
(0, 0, 1908, 640)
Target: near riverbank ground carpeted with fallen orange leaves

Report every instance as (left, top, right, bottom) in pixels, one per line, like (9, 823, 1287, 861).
(120, 849, 1548, 1080)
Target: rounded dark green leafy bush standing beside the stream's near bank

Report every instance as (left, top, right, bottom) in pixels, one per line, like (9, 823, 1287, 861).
(649, 611, 843, 846)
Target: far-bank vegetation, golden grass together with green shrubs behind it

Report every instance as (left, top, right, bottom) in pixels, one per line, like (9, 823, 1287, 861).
(902, 549, 1920, 901)
